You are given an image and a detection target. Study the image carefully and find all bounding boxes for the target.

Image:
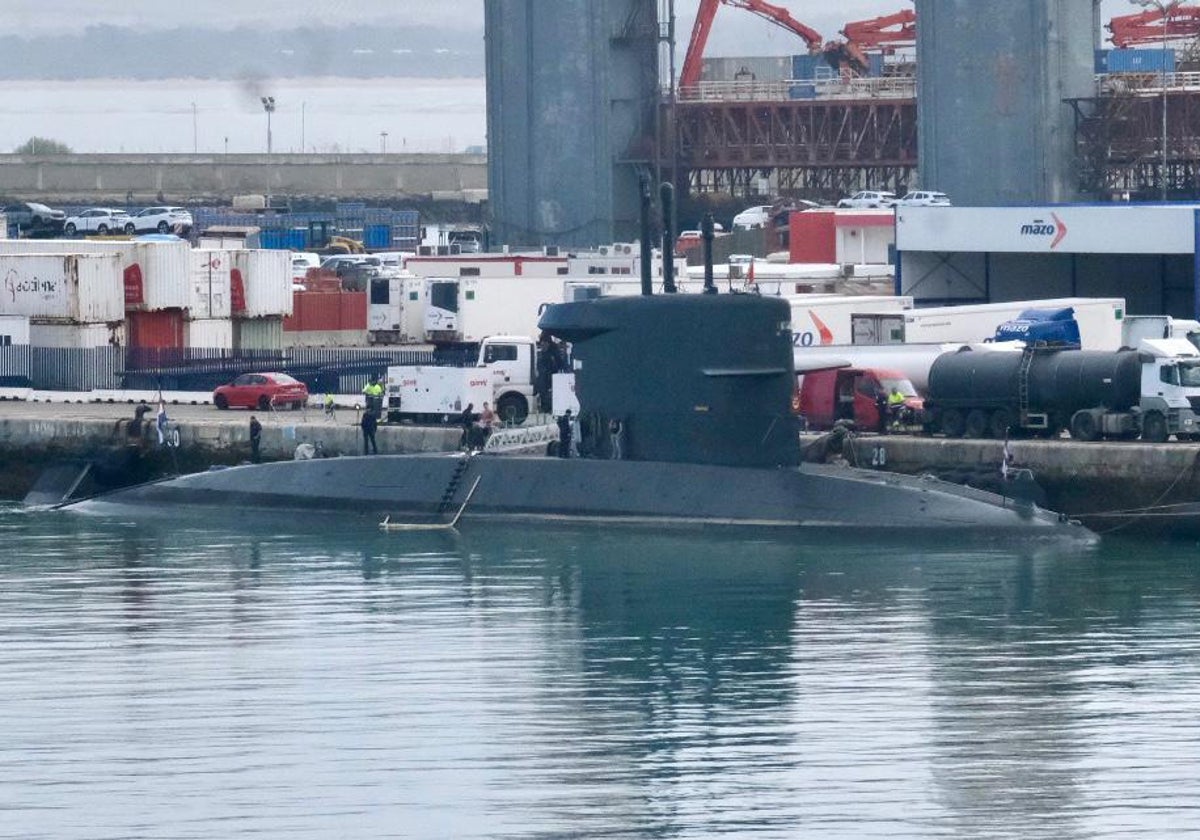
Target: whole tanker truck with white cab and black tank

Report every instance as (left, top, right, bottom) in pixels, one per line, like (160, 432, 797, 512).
(925, 338, 1200, 443)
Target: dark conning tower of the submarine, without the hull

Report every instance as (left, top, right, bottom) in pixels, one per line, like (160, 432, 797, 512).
(539, 294, 799, 467)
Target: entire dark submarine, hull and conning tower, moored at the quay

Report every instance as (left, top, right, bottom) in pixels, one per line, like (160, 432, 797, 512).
(74, 294, 1092, 540)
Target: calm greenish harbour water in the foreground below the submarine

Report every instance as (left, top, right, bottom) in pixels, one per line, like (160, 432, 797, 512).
(0, 508, 1200, 840)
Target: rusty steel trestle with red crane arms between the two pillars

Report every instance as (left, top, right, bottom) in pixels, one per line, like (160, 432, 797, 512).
(660, 0, 917, 198)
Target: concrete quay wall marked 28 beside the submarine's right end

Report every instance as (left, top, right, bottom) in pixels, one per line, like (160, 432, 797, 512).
(846, 434, 1200, 533)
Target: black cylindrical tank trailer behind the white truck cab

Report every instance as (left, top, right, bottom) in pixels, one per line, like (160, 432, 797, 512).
(925, 349, 1144, 439)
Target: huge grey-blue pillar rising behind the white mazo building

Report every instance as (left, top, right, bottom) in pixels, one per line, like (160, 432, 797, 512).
(916, 0, 1096, 205)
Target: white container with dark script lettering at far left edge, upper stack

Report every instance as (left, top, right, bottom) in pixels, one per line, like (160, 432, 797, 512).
(0, 253, 125, 324)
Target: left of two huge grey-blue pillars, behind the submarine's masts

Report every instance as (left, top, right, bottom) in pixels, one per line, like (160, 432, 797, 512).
(485, 0, 658, 246)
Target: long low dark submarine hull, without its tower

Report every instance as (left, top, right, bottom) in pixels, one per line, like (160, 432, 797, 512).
(70, 454, 1090, 536)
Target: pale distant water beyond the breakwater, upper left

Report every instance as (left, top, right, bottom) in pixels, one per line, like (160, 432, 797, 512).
(0, 78, 487, 155)
